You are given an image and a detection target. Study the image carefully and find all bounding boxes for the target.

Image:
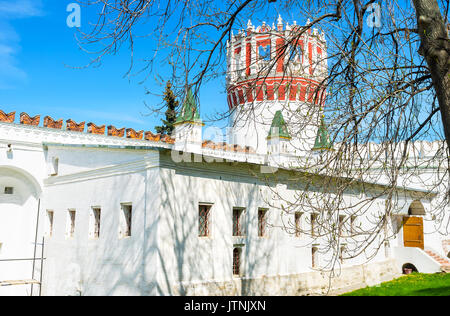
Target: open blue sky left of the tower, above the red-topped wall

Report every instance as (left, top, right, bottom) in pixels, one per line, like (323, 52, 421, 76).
(0, 0, 227, 131)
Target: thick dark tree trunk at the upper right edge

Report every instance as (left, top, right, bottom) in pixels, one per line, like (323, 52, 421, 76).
(413, 0, 450, 149)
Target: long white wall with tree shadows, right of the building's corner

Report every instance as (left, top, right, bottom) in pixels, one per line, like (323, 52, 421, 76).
(154, 154, 412, 295)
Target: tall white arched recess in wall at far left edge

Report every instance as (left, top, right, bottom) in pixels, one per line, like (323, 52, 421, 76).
(0, 166, 41, 296)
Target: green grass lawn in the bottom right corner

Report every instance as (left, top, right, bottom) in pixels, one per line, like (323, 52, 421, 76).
(342, 273, 450, 296)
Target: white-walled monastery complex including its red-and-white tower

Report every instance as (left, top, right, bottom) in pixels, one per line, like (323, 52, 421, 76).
(0, 19, 450, 295)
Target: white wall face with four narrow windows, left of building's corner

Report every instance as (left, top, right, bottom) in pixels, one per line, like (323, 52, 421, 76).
(40, 148, 159, 295)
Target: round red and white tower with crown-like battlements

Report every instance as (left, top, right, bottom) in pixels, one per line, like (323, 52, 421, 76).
(227, 17, 327, 154)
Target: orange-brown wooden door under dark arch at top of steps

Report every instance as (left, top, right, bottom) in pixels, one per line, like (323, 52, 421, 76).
(403, 201, 425, 249)
